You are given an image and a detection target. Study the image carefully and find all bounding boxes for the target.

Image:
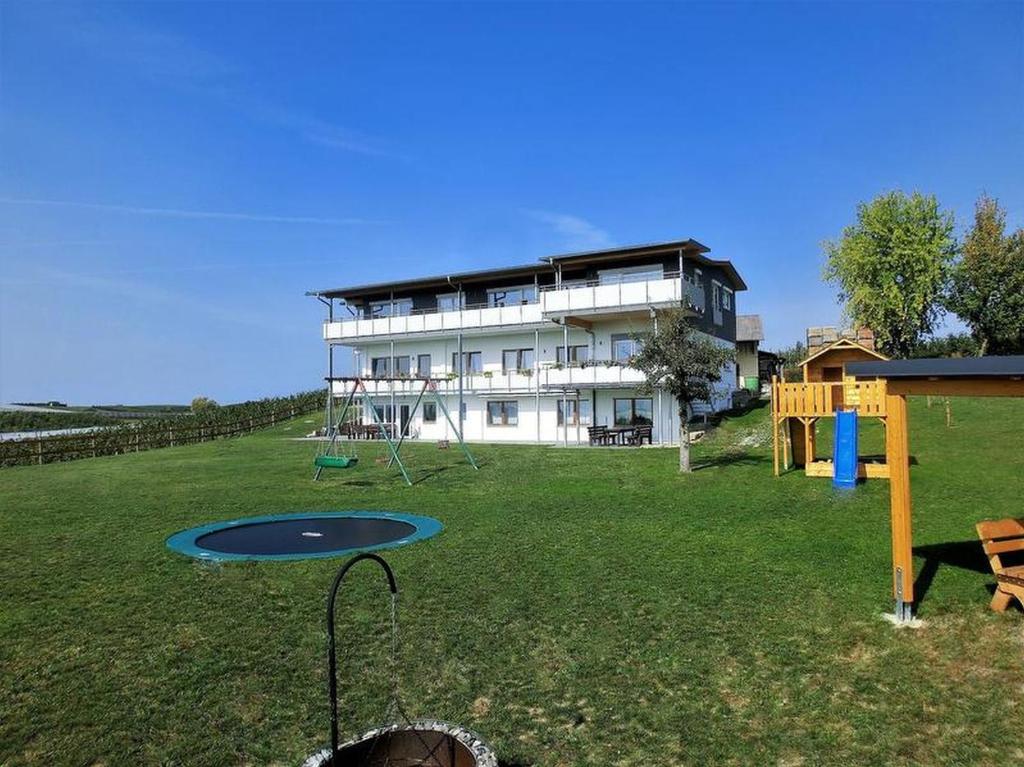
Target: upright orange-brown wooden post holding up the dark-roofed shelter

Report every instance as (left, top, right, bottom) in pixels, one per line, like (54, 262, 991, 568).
(886, 394, 913, 622)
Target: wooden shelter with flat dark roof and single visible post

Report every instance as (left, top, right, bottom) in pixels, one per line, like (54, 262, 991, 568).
(846, 355, 1024, 622)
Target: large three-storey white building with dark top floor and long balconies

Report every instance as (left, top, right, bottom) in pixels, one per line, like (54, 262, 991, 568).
(309, 240, 746, 443)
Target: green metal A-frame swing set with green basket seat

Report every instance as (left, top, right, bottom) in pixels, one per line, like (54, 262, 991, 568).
(313, 376, 480, 485)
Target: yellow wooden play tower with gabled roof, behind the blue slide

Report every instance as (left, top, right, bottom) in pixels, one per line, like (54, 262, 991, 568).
(771, 338, 889, 479)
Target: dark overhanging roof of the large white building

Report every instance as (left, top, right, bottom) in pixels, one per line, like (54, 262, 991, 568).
(306, 240, 746, 299)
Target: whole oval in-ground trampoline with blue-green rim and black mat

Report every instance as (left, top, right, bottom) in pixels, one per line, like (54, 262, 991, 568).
(167, 511, 442, 561)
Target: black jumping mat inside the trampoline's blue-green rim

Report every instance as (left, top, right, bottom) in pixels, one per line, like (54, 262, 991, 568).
(196, 516, 416, 555)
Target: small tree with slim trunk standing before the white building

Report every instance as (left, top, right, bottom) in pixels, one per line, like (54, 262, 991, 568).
(630, 309, 734, 472)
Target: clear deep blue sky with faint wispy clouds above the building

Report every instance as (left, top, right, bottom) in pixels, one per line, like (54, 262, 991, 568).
(0, 0, 1024, 403)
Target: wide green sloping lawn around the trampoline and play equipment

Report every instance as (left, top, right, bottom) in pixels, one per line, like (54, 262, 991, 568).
(0, 400, 1024, 767)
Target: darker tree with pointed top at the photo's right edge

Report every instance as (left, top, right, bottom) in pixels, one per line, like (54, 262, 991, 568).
(946, 195, 1024, 356)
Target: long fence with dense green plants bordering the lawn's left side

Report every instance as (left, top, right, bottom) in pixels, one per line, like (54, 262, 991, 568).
(0, 403, 322, 467)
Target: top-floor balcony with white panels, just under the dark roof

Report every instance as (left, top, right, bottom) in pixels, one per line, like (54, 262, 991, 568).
(324, 273, 706, 343)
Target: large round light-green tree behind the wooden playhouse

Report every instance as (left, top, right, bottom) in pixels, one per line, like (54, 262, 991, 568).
(824, 191, 956, 357)
